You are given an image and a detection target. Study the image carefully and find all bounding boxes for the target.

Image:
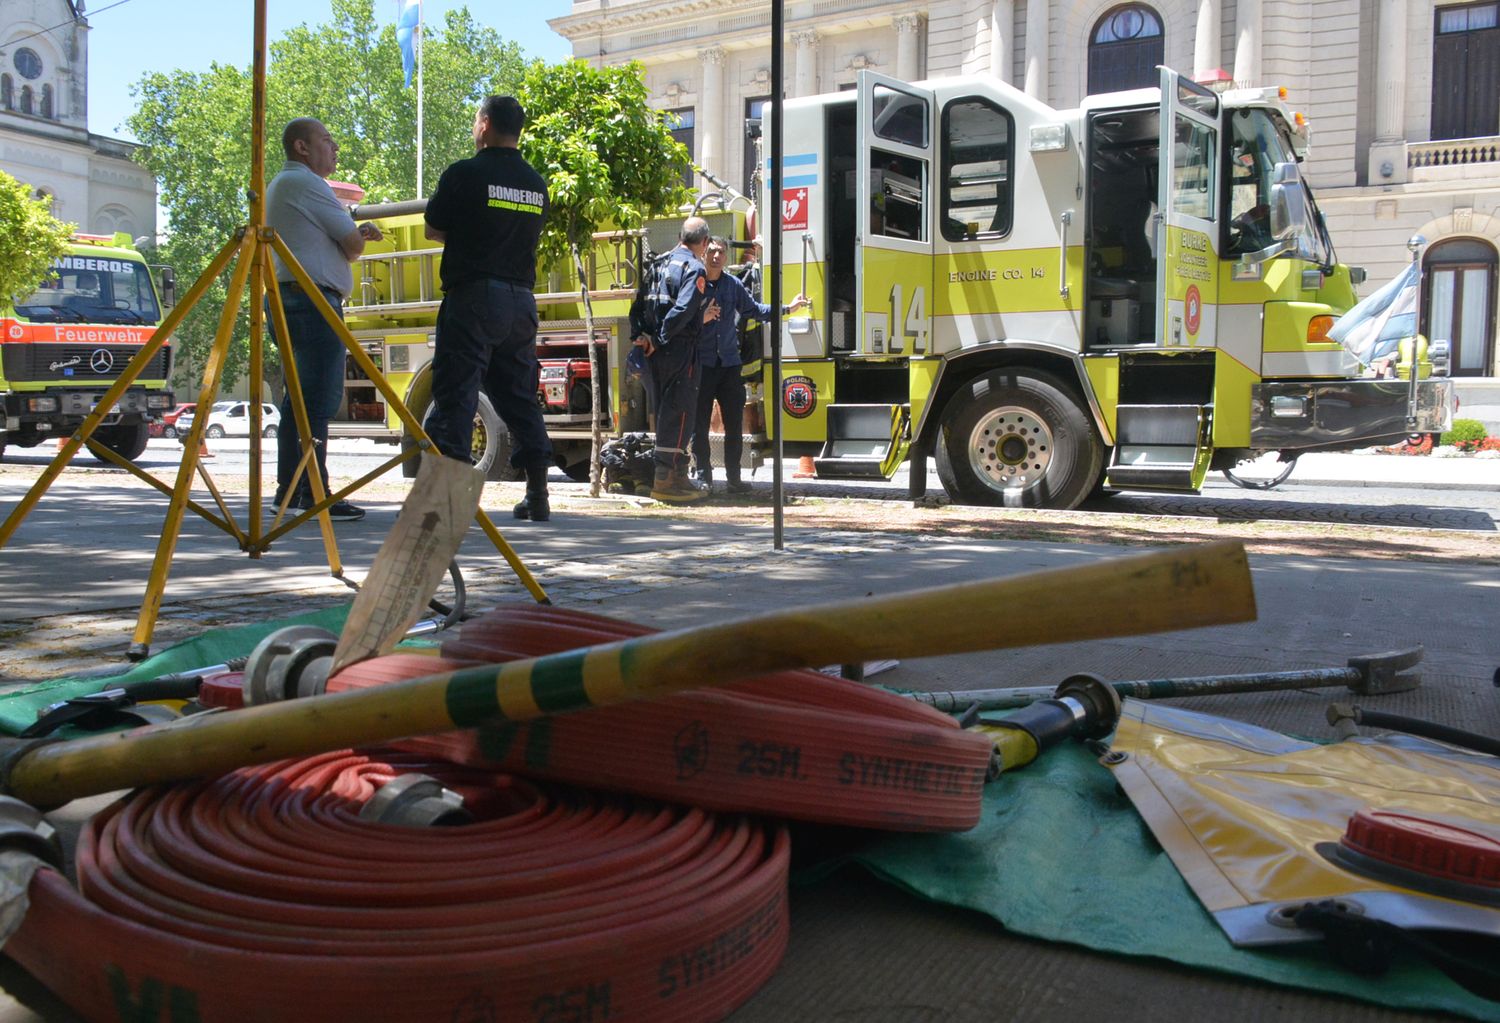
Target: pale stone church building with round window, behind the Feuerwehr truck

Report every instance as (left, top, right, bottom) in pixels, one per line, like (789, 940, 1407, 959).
(0, 0, 156, 239)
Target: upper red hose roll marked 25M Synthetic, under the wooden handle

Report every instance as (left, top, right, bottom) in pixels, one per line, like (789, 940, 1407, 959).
(329, 603, 993, 831)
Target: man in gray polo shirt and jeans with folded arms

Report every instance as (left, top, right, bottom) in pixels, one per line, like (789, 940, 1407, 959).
(266, 117, 381, 522)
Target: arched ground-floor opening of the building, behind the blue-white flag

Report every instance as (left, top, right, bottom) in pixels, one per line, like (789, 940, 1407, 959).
(1422, 239, 1496, 377)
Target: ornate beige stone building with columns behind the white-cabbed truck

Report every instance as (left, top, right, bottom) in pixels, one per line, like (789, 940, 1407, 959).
(551, 0, 1500, 378)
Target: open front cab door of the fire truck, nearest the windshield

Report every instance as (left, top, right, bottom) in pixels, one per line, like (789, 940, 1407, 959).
(1157, 68, 1224, 348)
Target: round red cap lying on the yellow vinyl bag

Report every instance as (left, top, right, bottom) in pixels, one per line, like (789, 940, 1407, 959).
(1340, 810, 1500, 890)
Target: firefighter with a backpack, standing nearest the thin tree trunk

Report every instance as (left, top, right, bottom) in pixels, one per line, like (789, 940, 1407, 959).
(636, 216, 719, 504)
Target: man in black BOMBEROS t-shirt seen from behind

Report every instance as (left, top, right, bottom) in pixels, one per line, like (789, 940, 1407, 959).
(425, 96, 552, 522)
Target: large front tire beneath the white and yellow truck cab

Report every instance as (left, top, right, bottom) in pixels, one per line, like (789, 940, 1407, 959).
(936, 369, 1104, 509)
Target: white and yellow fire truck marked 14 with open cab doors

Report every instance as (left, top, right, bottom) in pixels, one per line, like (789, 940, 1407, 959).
(340, 69, 1454, 509)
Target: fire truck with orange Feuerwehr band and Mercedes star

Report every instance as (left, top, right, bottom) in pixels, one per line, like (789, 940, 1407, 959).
(0, 234, 174, 459)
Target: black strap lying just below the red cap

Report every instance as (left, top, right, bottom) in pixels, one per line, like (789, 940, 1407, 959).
(1292, 900, 1500, 1002)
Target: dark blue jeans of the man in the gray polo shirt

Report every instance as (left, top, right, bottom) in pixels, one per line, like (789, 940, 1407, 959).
(267, 284, 348, 494)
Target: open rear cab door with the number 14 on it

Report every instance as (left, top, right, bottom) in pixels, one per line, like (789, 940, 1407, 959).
(852, 71, 936, 359)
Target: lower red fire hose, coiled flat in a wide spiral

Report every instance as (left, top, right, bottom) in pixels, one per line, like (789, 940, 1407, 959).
(6, 752, 789, 1023)
